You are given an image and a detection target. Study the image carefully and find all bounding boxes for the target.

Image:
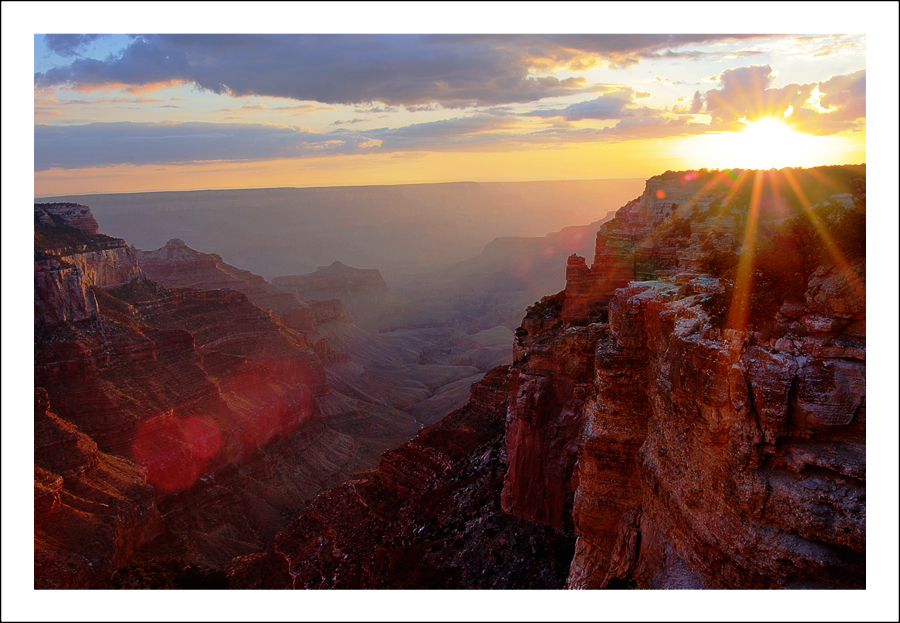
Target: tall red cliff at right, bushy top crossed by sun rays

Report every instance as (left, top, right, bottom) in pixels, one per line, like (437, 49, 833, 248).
(502, 167, 866, 588)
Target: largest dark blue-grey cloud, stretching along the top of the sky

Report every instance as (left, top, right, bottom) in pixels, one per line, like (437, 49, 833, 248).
(35, 34, 768, 108)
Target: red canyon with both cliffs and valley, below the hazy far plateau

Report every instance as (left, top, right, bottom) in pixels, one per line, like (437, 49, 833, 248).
(35, 166, 866, 589)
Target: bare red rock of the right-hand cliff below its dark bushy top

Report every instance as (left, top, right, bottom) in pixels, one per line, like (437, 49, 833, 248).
(503, 167, 865, 588)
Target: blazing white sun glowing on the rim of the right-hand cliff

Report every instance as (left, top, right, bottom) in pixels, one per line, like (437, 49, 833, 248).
(681, 117, 847, 169)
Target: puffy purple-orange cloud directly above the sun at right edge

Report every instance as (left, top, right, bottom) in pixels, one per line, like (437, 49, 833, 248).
(704, 65, 866, 134)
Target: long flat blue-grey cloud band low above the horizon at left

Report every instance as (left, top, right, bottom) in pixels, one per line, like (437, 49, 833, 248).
(34, 114, 528, 171)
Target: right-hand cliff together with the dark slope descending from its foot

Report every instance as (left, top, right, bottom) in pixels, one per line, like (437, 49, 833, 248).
(243, 167, 866, 589)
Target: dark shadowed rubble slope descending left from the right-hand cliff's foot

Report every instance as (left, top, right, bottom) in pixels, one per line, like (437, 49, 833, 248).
(229, 367, 573, 589)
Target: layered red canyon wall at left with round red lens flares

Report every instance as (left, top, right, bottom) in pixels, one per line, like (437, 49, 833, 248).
(34, 207, 419, 588)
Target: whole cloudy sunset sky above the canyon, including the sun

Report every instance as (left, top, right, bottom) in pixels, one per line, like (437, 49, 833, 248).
(22, 14, 880, 196)
